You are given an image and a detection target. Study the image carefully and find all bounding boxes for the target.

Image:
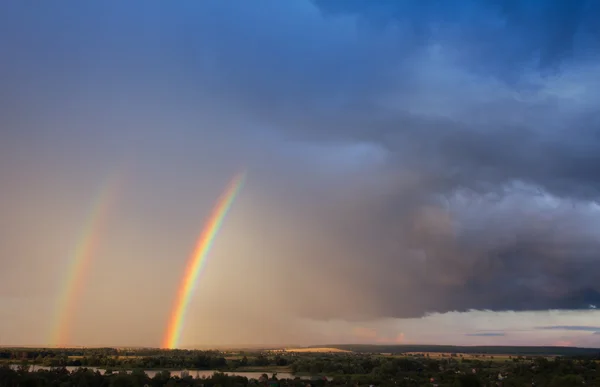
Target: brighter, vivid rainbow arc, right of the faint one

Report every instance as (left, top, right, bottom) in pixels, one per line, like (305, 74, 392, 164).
(163, 173, 246, 349)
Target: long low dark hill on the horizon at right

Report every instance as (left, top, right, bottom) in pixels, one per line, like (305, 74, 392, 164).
(308, 344, 600, 356)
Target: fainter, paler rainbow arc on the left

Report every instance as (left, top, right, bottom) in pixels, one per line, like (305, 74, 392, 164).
(51, 173, 123, 347)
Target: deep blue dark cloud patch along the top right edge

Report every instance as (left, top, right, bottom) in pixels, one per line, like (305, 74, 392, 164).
(314, 0, 600, 77)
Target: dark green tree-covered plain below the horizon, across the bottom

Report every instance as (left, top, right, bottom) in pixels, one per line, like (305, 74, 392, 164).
(0, 347, 600, 387)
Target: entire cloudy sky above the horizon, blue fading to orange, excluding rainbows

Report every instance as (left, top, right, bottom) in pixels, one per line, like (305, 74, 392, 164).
(0, 0, 600, 347)
